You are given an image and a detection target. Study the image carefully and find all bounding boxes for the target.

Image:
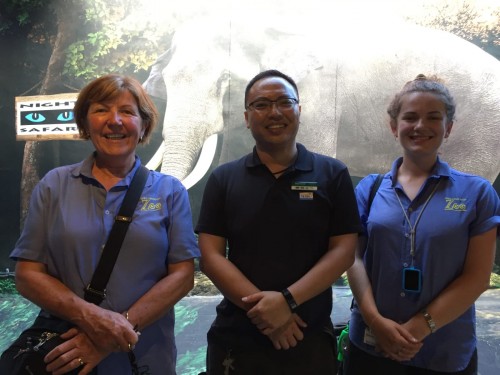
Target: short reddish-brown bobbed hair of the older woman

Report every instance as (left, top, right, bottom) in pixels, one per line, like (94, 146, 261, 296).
(73, 74, 159, 143)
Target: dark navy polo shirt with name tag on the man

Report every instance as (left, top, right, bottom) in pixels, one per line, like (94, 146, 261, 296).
(196, 144, 361, 345)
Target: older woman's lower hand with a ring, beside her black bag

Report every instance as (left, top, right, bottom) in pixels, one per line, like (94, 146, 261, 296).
(44, 328, 110, 375)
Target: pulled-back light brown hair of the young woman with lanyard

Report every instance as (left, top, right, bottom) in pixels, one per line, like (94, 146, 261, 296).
(387, 74, 456, 121)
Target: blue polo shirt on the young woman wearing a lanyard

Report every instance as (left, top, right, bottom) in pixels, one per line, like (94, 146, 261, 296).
(350, 158, 500, 372)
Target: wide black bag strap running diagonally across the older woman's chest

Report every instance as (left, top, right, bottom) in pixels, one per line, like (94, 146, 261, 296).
(85, 165, 149, 305)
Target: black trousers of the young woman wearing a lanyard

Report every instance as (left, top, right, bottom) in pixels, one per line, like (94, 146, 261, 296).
(343, 342, 477, 375)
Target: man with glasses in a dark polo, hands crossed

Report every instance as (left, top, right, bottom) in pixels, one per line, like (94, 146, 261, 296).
(196, 70, 361, 375)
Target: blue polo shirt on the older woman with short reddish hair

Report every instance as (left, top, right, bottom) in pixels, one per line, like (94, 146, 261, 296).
(10, 155, 199, 375)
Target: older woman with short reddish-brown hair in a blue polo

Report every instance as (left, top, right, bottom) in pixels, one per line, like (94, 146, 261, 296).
(4, 74, 199, 375)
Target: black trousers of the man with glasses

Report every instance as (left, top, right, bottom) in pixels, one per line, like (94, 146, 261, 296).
(207, 327, 337, 375)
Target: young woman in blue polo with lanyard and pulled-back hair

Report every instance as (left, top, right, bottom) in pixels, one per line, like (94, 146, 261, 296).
(345, 75, 500, 375)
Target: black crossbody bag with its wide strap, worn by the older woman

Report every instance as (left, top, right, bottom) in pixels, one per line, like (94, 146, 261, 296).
(0, 165, 149, 375)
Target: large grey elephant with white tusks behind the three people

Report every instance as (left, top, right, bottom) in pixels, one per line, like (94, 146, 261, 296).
(144, 16, 500, 187)
